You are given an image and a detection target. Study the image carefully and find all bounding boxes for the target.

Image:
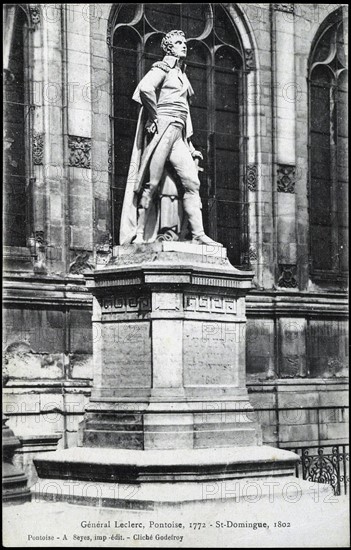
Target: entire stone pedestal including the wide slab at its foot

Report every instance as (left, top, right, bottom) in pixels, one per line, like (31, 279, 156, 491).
(34, 241, 298, 506)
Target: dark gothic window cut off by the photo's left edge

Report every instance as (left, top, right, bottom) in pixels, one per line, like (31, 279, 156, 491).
(4, 4, 30, 247)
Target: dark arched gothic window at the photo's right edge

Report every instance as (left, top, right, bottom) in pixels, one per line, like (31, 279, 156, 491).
(309, 11, 348, 279)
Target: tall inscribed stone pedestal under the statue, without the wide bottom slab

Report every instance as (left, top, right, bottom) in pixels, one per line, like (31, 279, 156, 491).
(81, 242, 261, 449)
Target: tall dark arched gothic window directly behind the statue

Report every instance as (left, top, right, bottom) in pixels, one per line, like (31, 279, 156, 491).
(111, 3, 247, 265)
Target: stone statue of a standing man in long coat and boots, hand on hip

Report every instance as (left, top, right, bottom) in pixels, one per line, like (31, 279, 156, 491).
(120, 30, 219, 245)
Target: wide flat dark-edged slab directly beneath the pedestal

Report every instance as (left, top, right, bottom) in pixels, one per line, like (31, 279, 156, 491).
(34, 446, 299, 483)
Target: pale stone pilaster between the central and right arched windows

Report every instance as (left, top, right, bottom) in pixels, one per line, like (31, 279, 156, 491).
(273, 4, 298, 288)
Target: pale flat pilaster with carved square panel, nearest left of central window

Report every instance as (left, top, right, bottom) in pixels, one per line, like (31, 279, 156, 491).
(64, 4, 94, 274)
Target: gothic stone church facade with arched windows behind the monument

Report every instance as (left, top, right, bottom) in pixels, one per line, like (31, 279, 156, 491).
(3, 3, 348, 488)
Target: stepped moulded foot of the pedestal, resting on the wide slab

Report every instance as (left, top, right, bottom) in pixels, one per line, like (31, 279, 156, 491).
(80, 402, 262, 451)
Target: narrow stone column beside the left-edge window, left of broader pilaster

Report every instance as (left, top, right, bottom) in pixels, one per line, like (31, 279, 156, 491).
(37, 4, 65, 273)
